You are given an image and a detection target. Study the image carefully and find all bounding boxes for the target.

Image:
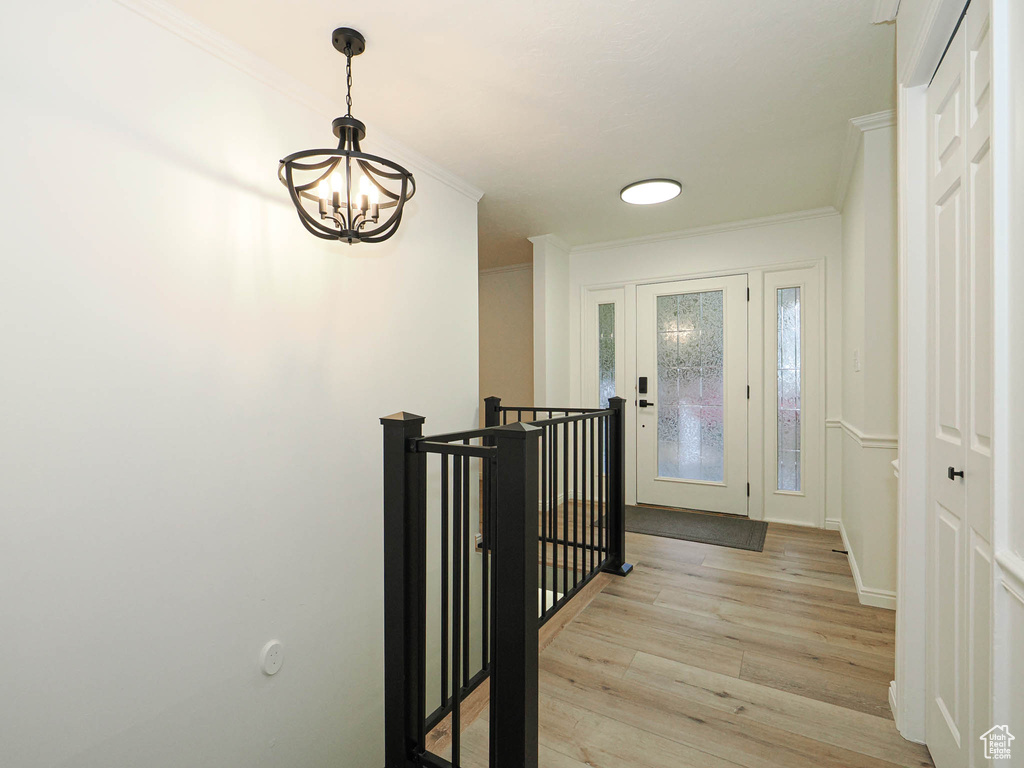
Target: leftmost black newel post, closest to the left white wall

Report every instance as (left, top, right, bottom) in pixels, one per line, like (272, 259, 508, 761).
(381, 413, 427, 768)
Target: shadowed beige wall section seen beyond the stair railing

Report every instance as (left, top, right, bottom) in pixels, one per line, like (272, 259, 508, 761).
(479, 264, 534, 420)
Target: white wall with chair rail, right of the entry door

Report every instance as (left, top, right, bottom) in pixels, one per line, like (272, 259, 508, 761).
(834, 121, 898, 608)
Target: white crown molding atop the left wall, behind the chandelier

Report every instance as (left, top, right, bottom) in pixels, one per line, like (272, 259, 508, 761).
(115, 0, 483, 203)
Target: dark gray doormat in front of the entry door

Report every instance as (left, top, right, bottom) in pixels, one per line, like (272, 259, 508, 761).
(626, 505, 768, 552)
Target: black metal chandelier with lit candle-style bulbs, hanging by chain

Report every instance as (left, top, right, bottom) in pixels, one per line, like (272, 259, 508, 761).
(278, 27, 416, 245)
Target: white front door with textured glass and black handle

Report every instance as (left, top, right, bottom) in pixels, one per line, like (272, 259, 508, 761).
(636, 274, 748, 515)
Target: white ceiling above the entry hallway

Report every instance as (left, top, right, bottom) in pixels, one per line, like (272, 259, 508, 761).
(161, 0, 895, 267)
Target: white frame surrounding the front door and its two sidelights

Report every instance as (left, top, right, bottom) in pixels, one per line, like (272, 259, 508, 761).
(579, 257, 827, 527)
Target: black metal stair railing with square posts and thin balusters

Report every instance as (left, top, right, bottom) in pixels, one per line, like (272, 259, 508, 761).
(381, 397, 632, 768)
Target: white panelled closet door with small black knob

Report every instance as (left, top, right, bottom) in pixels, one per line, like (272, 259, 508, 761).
(927, 0, 992, 768)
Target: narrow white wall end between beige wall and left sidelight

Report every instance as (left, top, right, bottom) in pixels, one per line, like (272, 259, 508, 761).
(529, 234, 574, 407)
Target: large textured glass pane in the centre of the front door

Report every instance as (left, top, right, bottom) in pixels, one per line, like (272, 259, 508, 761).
(657, 291, 725, 482)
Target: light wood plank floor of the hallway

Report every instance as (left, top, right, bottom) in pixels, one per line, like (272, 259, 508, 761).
(443, 524, 932, 768)
